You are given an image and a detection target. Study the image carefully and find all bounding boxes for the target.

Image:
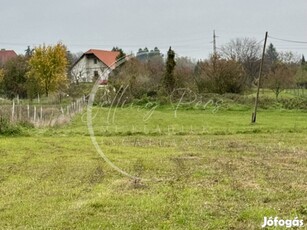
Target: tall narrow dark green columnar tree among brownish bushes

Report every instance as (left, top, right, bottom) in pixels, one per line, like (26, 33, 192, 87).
(164, 47, 176, 94)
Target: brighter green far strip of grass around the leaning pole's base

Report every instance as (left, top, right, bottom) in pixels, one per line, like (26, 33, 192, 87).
(51, 106, 307, 136)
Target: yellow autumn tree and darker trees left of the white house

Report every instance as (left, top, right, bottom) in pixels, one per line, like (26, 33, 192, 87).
(0, 43, 69, 98)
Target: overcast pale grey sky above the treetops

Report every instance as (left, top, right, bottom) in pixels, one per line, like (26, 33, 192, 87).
(0, 0, 307, 59)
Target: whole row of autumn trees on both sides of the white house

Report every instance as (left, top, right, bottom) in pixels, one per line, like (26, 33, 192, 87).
(0, 38, 307, 102)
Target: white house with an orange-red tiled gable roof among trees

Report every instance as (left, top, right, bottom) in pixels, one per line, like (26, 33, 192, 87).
(71, 49, 120, 85)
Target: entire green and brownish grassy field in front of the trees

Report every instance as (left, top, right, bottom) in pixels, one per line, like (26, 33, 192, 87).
(0, 106, 307, 229)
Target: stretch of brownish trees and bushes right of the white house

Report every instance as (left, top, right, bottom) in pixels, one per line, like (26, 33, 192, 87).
(110, 38, 307, 98)
